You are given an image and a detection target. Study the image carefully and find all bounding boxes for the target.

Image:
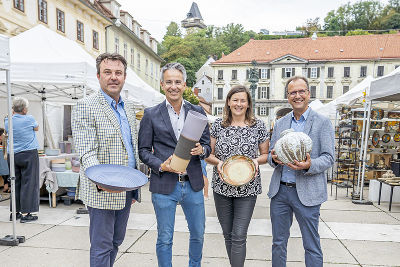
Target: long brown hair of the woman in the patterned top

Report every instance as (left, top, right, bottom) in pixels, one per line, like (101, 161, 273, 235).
(221, 85, 256, 127)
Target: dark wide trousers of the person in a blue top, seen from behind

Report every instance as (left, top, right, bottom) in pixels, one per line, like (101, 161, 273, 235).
(8, 149, 39, 213)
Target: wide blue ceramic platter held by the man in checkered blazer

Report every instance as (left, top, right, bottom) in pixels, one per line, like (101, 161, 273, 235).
(85, 164, 149, 191)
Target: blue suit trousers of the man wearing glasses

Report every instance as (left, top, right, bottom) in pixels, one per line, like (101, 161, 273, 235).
(270, 185, 323, 267)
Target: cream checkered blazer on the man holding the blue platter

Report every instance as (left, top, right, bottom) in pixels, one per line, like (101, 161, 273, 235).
(72, 91, 140, 210)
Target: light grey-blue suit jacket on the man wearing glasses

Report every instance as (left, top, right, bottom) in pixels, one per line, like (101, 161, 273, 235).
(268, 110, 335, 206)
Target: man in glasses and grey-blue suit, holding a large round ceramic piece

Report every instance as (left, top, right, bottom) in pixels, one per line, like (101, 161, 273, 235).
(268, 76, 335, 267)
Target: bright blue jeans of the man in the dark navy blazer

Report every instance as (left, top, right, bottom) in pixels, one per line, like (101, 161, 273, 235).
(151, 181, 205, 267)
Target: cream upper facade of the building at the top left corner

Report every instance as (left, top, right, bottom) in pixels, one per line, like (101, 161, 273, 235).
(0, 0, 111, 57)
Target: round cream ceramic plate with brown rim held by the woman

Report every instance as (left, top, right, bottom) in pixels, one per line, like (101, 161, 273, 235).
(221, 155, 256, 186)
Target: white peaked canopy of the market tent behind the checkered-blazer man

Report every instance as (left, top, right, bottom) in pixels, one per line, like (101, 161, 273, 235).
(0, 25, 163, 107)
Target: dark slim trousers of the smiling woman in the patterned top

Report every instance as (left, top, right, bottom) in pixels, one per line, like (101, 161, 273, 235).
(214, 192, 257, 267)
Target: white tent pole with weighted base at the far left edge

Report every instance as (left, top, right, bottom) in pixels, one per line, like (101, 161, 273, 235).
(0, 70, 25, 246)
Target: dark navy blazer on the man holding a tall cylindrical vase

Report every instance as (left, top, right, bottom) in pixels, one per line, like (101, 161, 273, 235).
(138, 100, 211, 194)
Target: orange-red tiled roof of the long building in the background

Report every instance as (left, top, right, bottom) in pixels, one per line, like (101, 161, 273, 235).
(212, 34, 400, 64)
